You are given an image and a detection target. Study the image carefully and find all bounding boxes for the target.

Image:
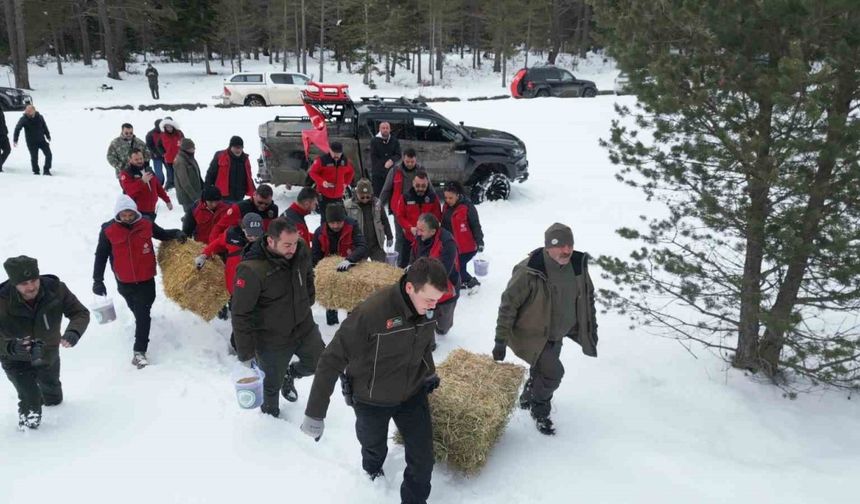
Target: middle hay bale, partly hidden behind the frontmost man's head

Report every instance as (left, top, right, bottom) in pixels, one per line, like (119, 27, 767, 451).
(314, 256, 403, 311)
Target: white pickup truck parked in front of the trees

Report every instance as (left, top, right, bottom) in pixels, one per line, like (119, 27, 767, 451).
(217, 72, 312, 107)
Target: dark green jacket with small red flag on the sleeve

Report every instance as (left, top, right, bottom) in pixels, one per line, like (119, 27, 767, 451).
(230, 236, 316, 361)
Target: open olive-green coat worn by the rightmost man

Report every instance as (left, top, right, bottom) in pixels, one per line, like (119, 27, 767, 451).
(496, 248, 597, 366)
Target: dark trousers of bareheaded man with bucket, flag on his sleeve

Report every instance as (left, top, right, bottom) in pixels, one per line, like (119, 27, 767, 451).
(256, 313, 325, 408)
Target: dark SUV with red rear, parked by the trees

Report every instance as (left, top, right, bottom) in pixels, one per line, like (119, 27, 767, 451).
(511, 66, 597, 98)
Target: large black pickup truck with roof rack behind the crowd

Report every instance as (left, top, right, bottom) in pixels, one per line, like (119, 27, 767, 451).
(258, 97, 529, 203)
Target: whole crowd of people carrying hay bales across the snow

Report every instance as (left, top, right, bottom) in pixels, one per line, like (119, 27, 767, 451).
(0, 118, 597, 503)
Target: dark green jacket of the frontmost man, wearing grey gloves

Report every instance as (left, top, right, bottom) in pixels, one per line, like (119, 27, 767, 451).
(305, 279, 436, 418)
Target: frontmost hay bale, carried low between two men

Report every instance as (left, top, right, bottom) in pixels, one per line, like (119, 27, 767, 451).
(396, 348, 525, 476)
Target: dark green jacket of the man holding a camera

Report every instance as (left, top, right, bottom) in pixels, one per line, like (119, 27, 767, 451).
(0, 275, 90, 360)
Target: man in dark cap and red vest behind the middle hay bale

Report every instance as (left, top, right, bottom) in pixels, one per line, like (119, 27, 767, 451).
(313, 203, 367, 325)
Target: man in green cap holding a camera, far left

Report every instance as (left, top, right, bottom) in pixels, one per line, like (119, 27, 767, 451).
(0, 256, 90, 429)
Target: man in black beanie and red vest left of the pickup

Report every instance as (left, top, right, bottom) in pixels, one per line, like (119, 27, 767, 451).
(205, 136, 255, 205)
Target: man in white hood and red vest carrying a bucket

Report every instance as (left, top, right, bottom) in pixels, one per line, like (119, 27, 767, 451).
(93, 194, 186, 369)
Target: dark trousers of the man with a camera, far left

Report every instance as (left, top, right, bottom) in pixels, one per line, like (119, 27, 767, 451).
(2, 350, 63, 414)
